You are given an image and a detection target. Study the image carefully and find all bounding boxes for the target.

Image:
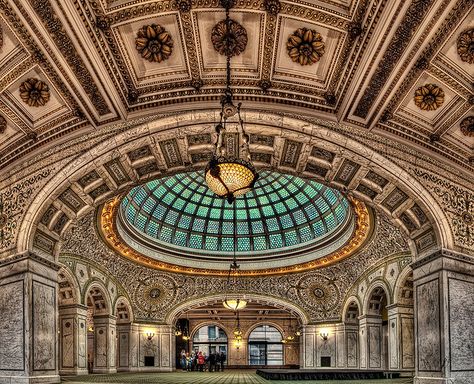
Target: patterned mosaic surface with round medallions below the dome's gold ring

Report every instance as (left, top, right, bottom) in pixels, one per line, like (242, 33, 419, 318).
(62, 206, 408, 321)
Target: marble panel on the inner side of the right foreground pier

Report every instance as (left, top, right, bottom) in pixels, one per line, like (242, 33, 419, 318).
(416, 279, 441, 372)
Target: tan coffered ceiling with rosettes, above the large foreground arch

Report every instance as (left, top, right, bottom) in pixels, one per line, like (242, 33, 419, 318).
(0, 0, 474, 170)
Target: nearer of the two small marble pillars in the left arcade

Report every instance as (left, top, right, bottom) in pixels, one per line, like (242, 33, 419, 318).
(59, 304, 87, 375)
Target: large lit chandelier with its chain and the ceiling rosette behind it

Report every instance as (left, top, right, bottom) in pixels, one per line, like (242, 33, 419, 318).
(205, 0, 258, 204)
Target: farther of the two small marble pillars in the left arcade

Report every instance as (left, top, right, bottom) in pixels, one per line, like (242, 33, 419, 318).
(93, 315, 117, 373)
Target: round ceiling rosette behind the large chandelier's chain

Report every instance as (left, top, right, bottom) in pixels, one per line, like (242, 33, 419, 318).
(211, 19, 248, 56)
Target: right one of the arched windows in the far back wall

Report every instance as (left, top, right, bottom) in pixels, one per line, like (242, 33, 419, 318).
(248, 324, 284, 366)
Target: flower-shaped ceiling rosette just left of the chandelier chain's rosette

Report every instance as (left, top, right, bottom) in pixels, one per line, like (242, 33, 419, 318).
(135, 24, 173, 63)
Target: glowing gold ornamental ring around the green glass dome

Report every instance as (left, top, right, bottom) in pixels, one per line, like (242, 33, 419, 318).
(97, 184, 374, 276)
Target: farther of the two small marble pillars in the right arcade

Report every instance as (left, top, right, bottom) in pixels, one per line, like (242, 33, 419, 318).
(359, 315, 384, 370)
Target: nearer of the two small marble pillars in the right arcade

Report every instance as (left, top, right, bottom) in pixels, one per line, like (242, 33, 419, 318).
(387, 304, 415, 372)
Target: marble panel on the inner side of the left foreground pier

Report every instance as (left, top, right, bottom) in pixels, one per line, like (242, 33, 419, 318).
(32, 281, 57, 371)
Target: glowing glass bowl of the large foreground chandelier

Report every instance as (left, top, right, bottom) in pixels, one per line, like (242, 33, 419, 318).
(206, 157, 258, 202)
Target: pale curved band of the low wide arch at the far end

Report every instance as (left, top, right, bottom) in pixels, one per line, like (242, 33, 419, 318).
(165, 293, 309, 325)
